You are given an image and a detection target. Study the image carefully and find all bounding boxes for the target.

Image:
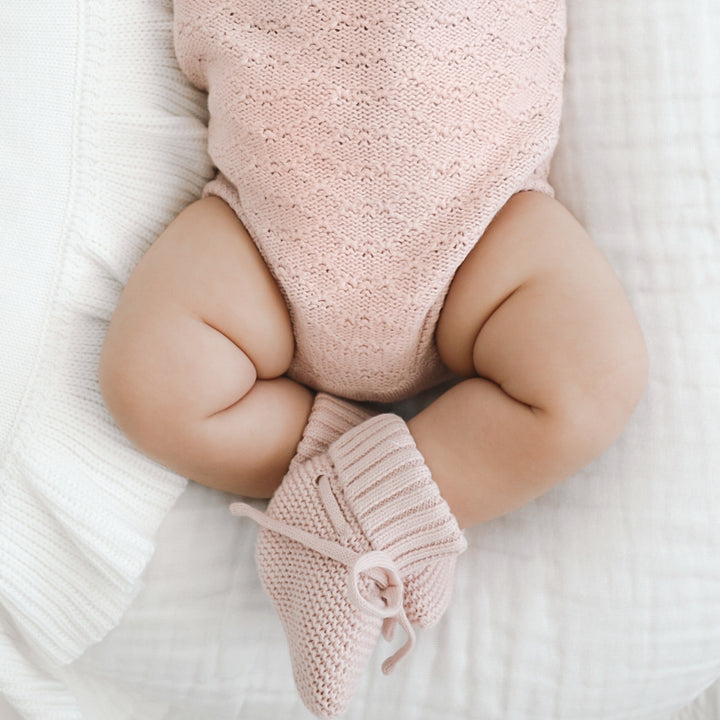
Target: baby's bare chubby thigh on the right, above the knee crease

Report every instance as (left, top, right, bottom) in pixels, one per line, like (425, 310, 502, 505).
(436, 192, 647, 464)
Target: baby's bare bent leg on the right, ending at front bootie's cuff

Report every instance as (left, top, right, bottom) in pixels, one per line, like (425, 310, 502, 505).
(416, 192, 647, 526)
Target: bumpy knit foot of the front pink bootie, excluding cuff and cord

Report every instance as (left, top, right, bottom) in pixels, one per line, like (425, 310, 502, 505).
(256, 458, 382, 717)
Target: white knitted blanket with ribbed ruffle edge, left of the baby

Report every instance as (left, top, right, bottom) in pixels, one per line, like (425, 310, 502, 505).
(0, 0, 198, 720)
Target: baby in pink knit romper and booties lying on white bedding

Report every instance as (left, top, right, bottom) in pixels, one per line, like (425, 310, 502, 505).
(100, 0, 647, 717)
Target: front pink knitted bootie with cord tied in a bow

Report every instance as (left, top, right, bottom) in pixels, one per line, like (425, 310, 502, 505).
(231, 414, 466, 717)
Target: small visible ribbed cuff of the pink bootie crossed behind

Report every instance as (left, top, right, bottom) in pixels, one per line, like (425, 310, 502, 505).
(290, 392, 373, 468)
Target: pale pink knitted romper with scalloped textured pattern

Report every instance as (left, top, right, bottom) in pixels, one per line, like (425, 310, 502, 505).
(174, 0, 565, 401)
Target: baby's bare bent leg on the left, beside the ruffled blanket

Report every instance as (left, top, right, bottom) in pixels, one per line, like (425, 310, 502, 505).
(100, 197, 313, 497)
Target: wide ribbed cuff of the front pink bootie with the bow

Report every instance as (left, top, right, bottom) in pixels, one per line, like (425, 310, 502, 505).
(328, 414, 467, 575)
